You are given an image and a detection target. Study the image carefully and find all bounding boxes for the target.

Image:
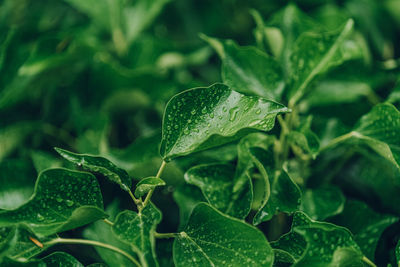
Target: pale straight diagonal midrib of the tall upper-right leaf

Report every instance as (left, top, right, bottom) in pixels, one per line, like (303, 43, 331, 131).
(288, 19, 354, 108)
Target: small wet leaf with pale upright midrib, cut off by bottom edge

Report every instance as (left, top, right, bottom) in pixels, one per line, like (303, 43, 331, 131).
(112, 203, 162, 266)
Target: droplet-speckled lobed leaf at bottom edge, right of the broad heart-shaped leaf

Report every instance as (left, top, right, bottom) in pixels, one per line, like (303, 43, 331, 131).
(271, 212, 362, 266)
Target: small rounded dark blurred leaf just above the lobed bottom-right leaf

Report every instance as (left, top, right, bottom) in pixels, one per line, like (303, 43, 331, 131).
(300, 185, 346, 220)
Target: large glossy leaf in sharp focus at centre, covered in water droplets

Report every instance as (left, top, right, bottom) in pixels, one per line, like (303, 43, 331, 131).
(161, 84, 289, 161)
